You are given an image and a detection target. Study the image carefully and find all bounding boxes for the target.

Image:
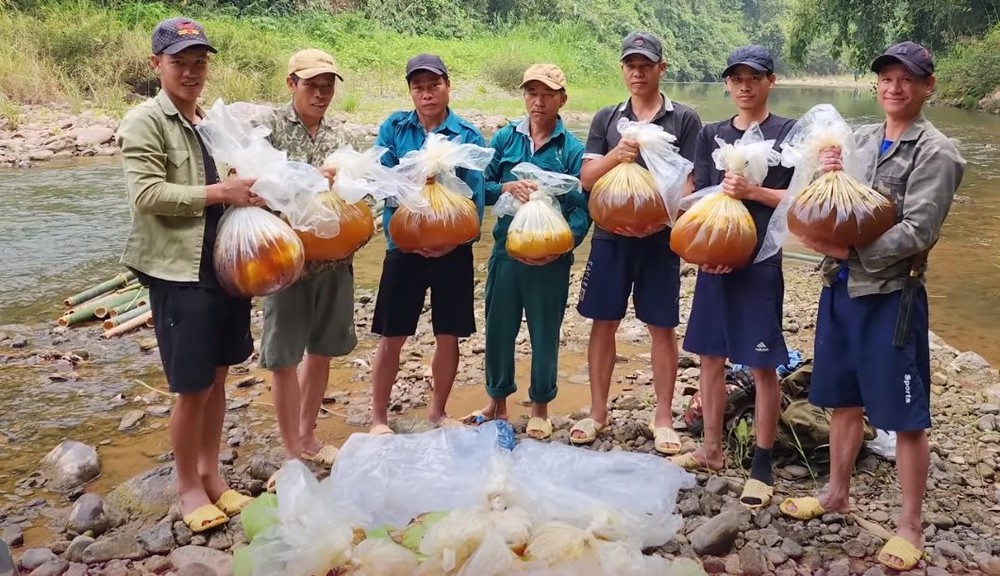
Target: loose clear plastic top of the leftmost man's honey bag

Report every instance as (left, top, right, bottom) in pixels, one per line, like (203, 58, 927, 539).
(197, 98, 339, 238)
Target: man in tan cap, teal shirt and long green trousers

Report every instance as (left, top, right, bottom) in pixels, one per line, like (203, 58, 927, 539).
(467, 64, 590, 439)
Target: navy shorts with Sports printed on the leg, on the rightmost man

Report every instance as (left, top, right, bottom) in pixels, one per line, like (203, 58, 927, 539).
(809, 281, 931, 432)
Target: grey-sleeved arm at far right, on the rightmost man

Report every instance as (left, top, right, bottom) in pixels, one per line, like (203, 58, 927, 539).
(855, 142, 965, 272)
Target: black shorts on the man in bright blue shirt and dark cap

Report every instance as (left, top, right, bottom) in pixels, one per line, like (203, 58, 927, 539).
(372, 244, 476, 338)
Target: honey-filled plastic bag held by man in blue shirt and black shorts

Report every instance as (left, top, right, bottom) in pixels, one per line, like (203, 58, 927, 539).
(389, 133, 493, 252)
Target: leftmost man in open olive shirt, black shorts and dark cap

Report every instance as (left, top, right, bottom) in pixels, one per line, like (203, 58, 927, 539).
(117, 18, 264, 532)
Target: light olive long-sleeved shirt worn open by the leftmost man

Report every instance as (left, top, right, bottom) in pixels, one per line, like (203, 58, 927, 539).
(116, 90, 216, 283)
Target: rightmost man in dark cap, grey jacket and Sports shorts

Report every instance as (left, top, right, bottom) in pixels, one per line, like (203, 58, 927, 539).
(781, 42, 965, 571)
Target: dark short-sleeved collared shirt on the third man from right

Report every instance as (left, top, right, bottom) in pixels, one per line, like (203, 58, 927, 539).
(583, 94, 701, 240)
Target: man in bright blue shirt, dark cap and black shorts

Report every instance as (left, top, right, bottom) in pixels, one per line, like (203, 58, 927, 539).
(371, 54, 486, 434)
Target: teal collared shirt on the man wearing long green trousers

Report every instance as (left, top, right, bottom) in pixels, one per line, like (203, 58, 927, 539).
(486, 118, 590, 258)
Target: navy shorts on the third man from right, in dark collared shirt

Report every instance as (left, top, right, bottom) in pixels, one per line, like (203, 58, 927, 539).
(576, 230, 681, 328)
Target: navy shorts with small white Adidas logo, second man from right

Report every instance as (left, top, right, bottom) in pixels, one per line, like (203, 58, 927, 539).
(684, 264, 788, 368)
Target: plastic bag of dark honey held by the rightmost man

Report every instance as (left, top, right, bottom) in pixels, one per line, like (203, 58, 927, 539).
(757, 104, 896, 261)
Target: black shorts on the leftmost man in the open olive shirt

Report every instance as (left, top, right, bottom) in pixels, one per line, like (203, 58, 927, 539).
(149, 283, 253, 394)
